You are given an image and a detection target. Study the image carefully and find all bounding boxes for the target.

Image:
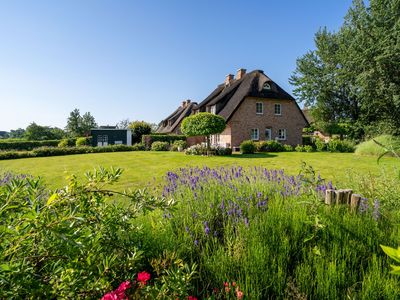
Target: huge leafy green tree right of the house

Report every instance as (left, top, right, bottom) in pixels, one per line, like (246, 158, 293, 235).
(290, 0, 400, 135)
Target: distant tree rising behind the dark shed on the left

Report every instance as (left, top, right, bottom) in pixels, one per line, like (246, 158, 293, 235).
(65, 108, 97, 137)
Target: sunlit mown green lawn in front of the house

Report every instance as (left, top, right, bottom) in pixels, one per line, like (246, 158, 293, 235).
(0, 152, 400, 189)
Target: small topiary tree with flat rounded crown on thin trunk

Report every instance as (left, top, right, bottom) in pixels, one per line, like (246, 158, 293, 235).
(181, 113, 226, 150)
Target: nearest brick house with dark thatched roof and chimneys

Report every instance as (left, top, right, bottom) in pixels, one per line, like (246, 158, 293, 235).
(158, 69, 308, 148)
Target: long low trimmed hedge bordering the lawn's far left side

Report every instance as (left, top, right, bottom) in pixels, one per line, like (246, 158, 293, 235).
(0, 144, 145, 160)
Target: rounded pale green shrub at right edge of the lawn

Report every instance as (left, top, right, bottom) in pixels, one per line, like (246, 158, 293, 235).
(355, 135, 400, 156)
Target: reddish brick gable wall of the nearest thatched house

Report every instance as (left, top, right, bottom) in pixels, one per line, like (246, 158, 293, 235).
(227, 97, 306, 147)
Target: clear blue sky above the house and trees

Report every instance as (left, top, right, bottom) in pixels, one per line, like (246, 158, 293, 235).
(0, 0, 351, 130)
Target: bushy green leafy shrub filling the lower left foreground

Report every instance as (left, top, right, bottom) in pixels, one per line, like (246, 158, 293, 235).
(0, 168, 170, 299)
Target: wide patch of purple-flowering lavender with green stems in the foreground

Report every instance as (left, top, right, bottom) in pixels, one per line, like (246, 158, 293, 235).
(144, 167, 400, 299)
